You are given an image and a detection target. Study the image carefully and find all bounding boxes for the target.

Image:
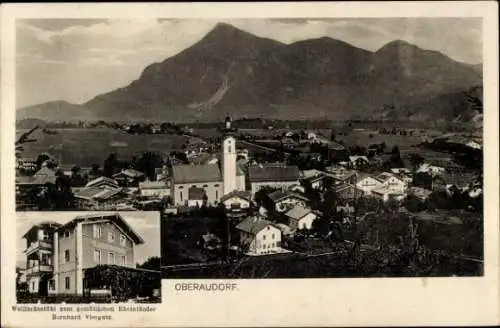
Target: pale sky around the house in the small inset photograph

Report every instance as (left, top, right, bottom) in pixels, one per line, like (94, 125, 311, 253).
(16, 212, 161, 266)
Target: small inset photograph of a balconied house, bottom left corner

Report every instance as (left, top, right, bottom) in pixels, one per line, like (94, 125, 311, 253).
(15, 211, 161, 303)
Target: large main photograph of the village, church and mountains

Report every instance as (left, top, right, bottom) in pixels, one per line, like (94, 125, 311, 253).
(16, 17, 483, 280)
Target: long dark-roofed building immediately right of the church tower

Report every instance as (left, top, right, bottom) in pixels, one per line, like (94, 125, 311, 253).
(248, 165, 299, 197)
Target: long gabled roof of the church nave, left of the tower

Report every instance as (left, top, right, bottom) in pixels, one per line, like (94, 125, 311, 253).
(172, 164, 222, 183)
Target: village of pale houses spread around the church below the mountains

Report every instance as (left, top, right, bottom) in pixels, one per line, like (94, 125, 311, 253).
(16, 117, 482, 278)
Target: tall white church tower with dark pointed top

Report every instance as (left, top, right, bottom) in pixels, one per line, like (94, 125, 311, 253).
(222, 117, 236, 195)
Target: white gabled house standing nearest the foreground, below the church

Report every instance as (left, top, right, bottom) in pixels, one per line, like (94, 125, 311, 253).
(236, 217, 281, 255)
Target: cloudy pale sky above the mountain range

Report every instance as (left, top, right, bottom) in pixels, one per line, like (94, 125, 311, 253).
(16, 18, 482, 108)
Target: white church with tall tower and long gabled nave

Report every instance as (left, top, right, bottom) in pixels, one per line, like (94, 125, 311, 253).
(171, 117, 245, 206)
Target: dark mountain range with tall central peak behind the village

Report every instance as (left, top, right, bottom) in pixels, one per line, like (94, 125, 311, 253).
(17, 23, 482, 121)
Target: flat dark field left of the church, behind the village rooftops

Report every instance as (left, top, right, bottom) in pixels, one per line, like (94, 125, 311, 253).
(18, 128, 188, 166)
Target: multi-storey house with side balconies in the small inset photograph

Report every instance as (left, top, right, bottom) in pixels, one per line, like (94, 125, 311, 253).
(23, 214, 144, 296)
